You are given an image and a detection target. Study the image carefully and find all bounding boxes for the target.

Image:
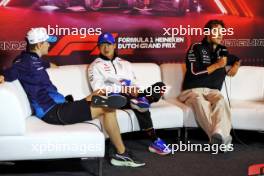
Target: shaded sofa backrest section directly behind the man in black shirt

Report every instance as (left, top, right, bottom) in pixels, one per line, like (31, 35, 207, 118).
(160, 63, 230, 99)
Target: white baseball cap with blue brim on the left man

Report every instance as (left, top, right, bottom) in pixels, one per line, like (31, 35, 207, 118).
(26, 27, 57, 44)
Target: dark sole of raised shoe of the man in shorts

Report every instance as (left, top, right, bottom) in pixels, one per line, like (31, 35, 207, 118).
(92, 95, 127, 109)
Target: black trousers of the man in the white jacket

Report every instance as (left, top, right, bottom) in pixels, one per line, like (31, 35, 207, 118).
(122, 82, 165, 130)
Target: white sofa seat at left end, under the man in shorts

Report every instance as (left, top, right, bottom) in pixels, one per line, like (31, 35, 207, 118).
(0, 116, 105, 161)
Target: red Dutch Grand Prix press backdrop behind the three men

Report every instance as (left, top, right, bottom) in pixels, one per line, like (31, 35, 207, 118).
(0, 0, 264, 70)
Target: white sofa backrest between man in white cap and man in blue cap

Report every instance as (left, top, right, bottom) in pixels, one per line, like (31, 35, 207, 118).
(47, 65, 91, 100)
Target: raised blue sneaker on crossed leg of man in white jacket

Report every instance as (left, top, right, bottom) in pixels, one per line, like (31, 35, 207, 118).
(130, 97, 150, 112)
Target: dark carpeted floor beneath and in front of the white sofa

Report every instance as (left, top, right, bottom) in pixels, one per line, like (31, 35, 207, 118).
(0, 129, 264, 176)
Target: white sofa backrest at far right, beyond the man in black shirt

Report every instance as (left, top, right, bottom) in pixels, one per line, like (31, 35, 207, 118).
(230, 66, 264, 100)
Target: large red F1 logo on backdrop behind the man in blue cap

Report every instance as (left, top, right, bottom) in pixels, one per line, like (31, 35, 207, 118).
(48, 33, 133, 56)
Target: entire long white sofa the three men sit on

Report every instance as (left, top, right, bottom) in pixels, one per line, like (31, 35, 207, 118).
(0, 63, 264, 172)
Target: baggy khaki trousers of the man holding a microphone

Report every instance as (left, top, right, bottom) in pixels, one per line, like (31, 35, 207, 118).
(178, 88, 231, 140)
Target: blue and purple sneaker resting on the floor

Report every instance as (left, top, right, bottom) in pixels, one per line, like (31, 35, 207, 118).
(149, 138, 171, 155)
